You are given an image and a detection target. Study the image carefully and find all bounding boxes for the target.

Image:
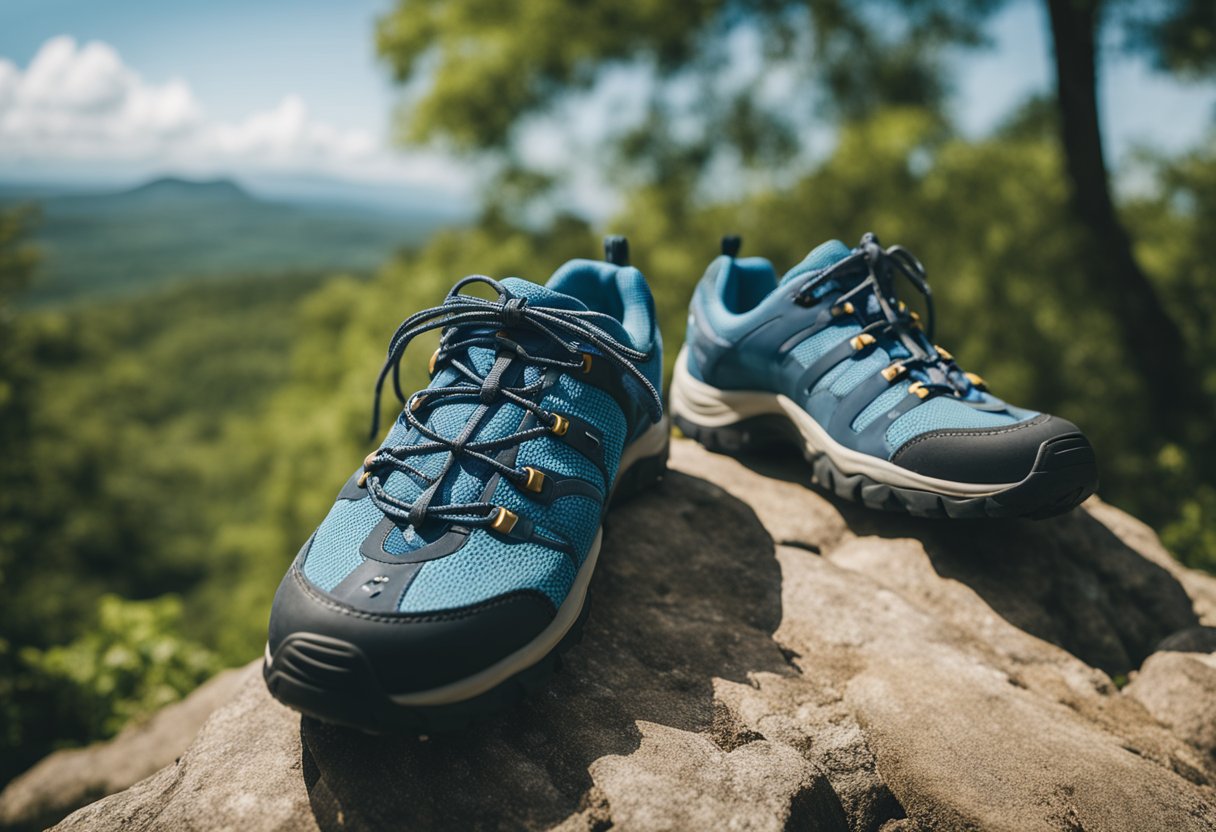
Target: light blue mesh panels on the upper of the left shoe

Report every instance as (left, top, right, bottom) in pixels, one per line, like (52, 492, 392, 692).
(303, 275, 662, 613)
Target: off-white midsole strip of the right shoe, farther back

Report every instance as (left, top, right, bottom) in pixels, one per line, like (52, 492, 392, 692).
(670, 347, 1017, 497)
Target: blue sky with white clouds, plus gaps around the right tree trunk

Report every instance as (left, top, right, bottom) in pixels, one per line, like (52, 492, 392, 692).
(0, 0, 1216, 208)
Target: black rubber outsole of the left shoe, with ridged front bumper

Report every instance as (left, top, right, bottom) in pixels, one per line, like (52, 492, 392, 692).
(261, 446, 668, 735)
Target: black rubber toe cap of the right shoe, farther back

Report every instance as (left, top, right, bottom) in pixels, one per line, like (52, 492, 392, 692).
(891, 414, 1097, 490)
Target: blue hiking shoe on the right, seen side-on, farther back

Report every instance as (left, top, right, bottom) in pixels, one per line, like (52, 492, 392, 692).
(670, 234, 1098, 518)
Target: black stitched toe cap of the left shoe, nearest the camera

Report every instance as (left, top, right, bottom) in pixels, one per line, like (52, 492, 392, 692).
(269, 564, 556, 695)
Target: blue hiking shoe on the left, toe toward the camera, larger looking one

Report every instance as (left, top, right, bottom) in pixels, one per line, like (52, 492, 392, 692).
(264, 237, 669, 733)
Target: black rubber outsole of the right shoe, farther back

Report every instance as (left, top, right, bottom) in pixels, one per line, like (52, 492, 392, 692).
(671, 414, 1098, 519)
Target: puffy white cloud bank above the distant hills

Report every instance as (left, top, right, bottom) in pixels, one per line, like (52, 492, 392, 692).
(0, 35, 467, 191)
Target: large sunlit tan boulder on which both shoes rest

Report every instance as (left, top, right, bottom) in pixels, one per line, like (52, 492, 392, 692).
(9, 443, 1216, 832)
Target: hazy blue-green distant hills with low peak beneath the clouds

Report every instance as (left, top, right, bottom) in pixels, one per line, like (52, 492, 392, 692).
(0, 176, 458, 304)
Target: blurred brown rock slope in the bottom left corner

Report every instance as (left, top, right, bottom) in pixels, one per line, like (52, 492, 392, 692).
(0, 665, 255, 830)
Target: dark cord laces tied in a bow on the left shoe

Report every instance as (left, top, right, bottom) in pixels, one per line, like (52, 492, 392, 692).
(360, 275, 663, 528)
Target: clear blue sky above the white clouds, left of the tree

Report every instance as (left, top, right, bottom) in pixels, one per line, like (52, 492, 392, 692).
(0, 0, 393, 133)
